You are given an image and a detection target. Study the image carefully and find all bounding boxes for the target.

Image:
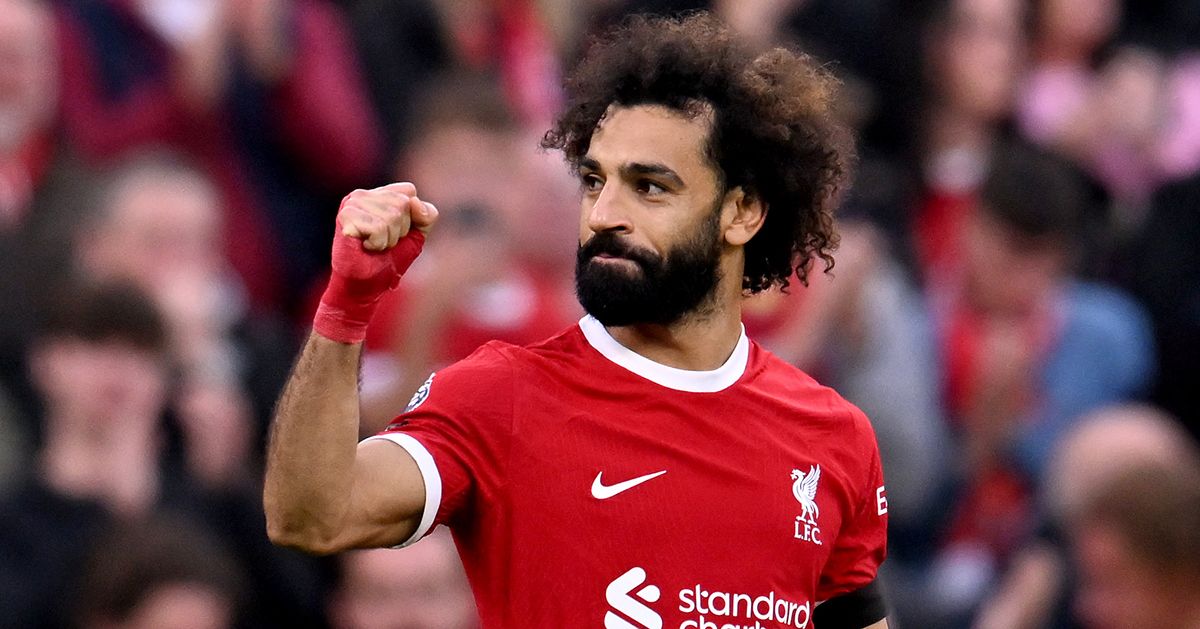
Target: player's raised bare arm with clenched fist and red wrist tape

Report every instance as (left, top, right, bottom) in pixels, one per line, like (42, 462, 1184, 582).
(263, 184, 437, 553)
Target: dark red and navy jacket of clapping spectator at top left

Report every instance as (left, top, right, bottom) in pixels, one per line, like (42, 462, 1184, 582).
(56, 0, 382, 305)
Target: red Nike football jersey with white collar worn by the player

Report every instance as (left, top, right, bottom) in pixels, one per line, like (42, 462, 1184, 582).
(372, 317, 887, 629)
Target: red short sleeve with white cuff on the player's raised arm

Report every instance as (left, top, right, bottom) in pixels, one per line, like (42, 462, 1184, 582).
(367, 343, 512, 546)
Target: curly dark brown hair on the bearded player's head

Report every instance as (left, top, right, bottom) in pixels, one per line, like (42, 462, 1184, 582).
(541, 12, 853, 293)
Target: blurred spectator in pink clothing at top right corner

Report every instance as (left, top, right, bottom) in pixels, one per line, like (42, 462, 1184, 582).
(1018, 0, 1200, 206)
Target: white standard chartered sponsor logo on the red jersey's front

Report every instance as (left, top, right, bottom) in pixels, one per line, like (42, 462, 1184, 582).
(604, 567, 812, 629)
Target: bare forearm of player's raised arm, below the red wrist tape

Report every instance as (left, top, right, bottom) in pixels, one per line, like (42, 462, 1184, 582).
(263, 333, 362, 552)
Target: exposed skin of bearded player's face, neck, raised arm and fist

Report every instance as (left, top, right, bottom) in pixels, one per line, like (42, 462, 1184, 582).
(264, 106, 887, 629)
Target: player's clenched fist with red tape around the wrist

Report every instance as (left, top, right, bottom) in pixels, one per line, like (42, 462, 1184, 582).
(312, 182, 438, 343)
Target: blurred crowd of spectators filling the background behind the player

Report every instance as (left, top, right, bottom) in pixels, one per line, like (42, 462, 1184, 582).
(0, 0, 1200, 629)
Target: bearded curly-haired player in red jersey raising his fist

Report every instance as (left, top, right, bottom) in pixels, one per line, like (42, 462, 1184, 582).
(265, 14, 887, 629)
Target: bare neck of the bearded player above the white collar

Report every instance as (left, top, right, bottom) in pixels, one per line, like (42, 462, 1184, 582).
(607, 268, 742, 371)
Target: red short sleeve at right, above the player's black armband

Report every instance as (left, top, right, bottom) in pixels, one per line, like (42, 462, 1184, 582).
(817, 408, 888, 600)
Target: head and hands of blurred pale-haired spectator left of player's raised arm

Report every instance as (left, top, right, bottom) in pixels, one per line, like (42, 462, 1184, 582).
(74, 152, 292, 482)
